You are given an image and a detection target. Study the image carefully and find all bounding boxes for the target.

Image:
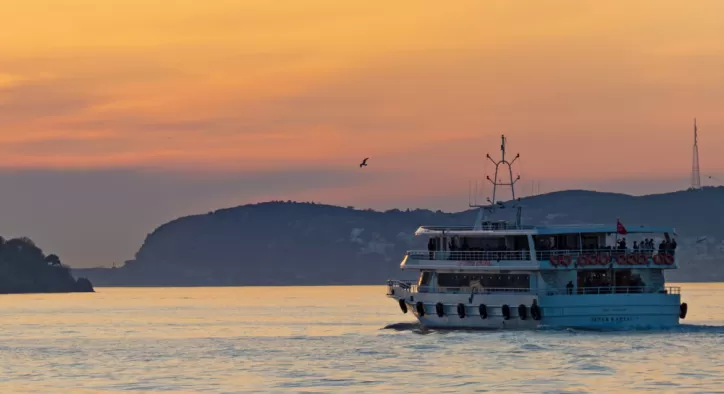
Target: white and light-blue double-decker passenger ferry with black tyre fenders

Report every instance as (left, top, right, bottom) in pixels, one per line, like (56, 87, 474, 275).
(387, 136, 687, 329)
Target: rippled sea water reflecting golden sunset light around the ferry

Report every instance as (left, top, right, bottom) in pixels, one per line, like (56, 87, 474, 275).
(0, 284, 724, 393)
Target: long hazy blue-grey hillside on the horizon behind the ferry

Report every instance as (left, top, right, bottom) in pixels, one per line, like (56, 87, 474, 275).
(79, 187, 724, 286)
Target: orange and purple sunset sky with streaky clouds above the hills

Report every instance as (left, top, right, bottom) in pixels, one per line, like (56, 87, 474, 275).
(0, 0, 724, 265)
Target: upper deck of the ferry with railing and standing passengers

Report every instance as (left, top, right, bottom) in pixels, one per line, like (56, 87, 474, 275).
(400, 222, 678, 271)
